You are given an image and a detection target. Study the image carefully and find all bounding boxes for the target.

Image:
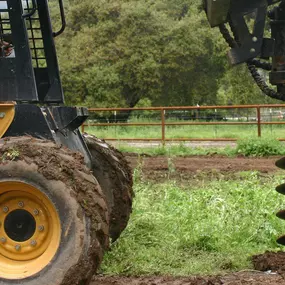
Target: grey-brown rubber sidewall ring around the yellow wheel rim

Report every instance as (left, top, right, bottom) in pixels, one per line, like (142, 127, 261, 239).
(0, 161, 90, 285)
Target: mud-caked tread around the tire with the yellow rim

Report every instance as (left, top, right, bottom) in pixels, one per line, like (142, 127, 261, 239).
(0, 137, 109, 285)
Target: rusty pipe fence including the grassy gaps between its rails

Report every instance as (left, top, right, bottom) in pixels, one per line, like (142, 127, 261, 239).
(82, 104, 285, 143)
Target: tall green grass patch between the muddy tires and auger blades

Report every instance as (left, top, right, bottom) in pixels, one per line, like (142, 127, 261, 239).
(101, 172, 285, 275)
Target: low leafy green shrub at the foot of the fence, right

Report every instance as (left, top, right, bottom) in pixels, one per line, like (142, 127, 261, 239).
(236, 138, 285, 156)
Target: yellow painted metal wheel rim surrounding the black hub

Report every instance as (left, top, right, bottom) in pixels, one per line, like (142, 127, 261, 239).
(0, 181, 61, 279)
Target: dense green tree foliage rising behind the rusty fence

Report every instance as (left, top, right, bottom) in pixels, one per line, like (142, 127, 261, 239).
(51, 0, 280, 107)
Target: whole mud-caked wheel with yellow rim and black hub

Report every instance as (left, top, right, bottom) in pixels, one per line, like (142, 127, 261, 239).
(0, 137, 109, 285)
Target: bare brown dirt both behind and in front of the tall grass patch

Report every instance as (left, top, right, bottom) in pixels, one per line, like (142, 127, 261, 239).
(92, 153, 285, 285)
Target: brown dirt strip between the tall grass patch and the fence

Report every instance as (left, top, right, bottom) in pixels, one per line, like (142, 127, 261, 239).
(127, 153, 280, 181)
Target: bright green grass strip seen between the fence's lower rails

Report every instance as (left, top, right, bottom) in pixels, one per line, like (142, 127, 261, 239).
(85, 125, 285, 140)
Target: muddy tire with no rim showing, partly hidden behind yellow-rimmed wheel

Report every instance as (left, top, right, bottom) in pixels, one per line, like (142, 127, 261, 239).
(84, 134, 134, 241)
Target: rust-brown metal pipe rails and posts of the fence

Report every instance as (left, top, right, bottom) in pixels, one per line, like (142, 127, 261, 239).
(82, 104, 285, 143)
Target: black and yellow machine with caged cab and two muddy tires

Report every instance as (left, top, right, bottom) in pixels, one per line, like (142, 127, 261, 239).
(0, 0, 133, 285)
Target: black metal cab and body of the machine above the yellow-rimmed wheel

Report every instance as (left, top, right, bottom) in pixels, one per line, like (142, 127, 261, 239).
(0, 0, 90, 164)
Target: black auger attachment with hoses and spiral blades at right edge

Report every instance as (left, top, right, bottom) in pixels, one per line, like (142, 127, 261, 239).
(203, 0, 285, 245)
